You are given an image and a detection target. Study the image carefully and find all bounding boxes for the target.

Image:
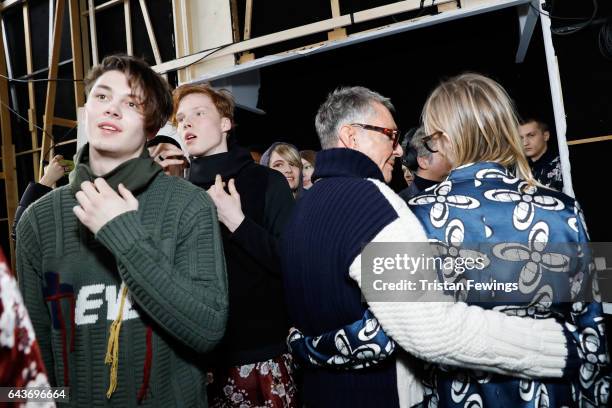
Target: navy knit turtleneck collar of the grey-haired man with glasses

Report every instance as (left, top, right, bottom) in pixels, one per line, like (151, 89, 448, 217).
(312, 148, 385, 183)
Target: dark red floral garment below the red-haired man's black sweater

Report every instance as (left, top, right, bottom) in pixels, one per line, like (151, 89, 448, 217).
(208, 353, 298, 408)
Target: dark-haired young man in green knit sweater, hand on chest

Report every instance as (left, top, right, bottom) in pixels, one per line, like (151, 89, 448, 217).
(17, 56, 228, 407)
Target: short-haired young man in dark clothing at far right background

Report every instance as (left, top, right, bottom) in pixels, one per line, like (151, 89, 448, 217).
(519, 118, 563, 191)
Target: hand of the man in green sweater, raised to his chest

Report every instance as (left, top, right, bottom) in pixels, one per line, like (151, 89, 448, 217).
(72, 178, 138, 234)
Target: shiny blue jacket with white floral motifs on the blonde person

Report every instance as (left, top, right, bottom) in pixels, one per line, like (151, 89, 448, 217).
(408, 162, 609, 408)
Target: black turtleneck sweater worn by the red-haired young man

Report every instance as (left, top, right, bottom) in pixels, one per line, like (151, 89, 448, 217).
(189, 146, 294, 366)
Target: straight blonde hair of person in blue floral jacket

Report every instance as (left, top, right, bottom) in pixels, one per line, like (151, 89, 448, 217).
(422, 73, 537, 186)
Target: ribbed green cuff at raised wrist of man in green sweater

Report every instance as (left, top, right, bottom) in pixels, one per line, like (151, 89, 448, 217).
(96, 211, 146, 254)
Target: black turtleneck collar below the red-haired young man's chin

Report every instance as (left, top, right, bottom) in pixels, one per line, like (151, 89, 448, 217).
(189, 146, 254, 189)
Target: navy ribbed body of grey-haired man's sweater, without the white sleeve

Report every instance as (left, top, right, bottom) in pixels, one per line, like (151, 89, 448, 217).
(281, 149, 398, 407)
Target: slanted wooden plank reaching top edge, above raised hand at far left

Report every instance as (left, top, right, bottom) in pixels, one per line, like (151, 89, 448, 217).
(38, 0, 66, 180)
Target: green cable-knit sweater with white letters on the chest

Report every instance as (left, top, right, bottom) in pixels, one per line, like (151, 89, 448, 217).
(17, 146, 228, 407)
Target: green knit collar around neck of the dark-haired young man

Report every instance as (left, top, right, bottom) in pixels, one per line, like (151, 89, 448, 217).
(68, 143, 162, 195)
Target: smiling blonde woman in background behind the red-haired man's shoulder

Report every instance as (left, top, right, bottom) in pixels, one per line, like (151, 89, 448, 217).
(259, 142, 303, 198)
